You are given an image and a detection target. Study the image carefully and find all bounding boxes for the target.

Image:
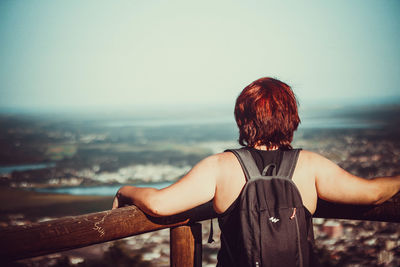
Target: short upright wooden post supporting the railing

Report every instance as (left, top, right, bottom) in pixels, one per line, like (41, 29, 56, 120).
(170, 223, 202, 267)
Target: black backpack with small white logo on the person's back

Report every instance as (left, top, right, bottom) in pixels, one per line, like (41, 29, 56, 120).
(227, 148, 318, 267)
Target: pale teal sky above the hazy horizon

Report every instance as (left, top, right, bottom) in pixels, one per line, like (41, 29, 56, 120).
(0, 0, 400, 113)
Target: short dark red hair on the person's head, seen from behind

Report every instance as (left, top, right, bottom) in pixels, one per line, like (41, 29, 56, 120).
(235, 78, 300, 149)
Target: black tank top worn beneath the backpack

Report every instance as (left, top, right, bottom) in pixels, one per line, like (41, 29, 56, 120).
(217, 148, 313, 267)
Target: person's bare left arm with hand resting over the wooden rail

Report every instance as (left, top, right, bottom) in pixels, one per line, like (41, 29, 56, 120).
(113, 154, 220, 216)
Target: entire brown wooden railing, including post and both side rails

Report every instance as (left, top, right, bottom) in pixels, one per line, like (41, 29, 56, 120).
(0, 194, 400, 266)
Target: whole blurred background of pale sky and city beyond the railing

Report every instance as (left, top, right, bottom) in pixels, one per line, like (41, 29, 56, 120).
(0, 0, 400, 266)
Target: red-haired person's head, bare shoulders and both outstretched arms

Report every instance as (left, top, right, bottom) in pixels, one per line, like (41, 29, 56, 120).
(113, 78, 400, 266)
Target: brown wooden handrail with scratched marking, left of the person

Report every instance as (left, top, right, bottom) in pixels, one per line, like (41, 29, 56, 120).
(0, 202, 217, 261)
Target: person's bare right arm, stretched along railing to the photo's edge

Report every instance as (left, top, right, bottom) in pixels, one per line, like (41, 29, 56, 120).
(309, 152, 400, 204)
